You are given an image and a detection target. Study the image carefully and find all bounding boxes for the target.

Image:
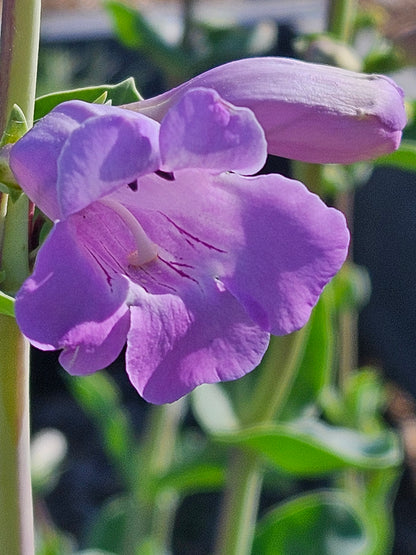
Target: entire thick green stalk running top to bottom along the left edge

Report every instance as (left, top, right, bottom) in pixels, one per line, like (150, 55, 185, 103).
(0, 0, 40, 555)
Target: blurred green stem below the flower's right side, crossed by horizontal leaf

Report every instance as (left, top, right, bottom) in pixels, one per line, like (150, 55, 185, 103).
(214, 326, 309, 555)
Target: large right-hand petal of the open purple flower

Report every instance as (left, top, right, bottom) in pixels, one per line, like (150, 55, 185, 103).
(220, 175, 349, 335)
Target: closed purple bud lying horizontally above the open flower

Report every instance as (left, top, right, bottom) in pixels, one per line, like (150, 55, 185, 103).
(126, 58, 406, 164)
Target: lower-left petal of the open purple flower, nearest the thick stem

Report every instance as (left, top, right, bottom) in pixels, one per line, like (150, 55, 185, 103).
(16, 218, 128, 374)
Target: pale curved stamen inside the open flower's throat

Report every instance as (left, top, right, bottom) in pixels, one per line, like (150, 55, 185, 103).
(100, 198, 157, 266)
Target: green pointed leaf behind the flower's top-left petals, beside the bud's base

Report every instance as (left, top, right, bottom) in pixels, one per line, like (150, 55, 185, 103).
(35, 77, 142, 120)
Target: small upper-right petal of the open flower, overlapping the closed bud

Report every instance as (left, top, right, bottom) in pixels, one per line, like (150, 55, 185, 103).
(160, 89, 267, 174)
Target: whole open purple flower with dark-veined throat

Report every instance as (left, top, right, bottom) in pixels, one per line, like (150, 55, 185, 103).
(11, 88, 349, 403)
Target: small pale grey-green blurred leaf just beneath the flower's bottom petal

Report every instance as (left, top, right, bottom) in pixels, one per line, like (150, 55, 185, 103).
(191, 384, 239, 434)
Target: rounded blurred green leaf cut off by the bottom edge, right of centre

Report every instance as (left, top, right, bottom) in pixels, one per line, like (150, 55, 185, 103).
(252, 490, 367, 555)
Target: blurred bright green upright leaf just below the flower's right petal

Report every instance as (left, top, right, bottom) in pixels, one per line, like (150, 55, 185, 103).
(281, 288, 334, 419)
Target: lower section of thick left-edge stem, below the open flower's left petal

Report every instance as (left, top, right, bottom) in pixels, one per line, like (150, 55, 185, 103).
(0, 315, 34, 555)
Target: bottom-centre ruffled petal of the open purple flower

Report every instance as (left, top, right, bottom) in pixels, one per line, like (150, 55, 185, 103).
(126, 282, 269, 404)
